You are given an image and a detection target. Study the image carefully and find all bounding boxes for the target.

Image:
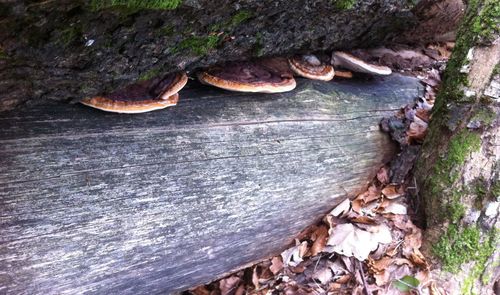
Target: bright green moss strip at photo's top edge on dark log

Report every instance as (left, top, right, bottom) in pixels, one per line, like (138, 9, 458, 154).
(90, 0, 182, 11)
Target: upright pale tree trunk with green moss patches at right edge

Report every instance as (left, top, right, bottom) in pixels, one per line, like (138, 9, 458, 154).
(416, 0, 500, 294)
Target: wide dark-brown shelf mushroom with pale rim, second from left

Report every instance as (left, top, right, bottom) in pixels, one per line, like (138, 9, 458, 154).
(198, 58, 296, 93)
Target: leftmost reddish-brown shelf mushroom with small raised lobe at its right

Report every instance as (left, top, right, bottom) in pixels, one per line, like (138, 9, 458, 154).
(80, 72, 188, 114)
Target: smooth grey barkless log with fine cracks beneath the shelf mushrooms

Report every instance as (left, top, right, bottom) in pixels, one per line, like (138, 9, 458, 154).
(0, 75, 420, 294)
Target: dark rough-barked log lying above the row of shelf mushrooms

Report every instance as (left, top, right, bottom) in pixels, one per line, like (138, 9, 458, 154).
(0, 0, 417, 111)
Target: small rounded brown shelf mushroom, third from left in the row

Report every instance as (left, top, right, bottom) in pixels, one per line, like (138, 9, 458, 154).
(288, 55, 335, 81)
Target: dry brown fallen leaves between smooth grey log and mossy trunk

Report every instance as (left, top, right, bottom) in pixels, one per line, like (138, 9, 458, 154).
(182, 45, 451, 295)
